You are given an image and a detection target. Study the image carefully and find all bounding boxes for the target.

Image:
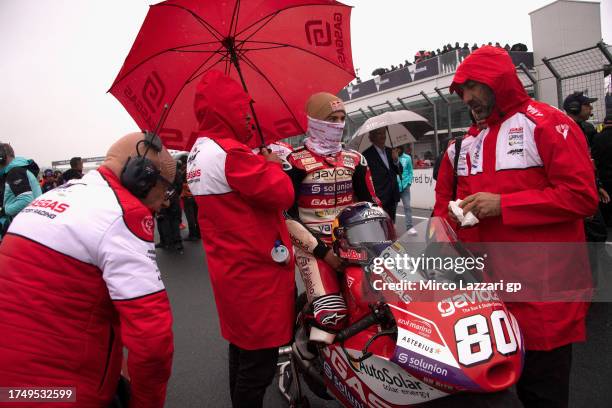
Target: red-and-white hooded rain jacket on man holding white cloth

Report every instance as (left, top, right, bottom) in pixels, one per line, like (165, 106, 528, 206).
(451, 47, 598, 350)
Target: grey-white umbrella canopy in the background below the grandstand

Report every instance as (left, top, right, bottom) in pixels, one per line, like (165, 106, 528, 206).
(348, 110, 433, 152)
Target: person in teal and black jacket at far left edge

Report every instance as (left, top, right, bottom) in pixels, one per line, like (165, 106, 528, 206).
(0, 143, 42, 237)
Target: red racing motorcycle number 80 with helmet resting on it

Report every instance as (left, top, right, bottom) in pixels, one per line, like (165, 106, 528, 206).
(279, 203, 524, 408)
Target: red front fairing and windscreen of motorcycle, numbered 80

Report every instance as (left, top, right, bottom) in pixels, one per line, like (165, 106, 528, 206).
(366, 218, 523, 393)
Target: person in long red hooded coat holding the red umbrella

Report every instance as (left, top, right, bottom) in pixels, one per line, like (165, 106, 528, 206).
(187, 71, 295, 407)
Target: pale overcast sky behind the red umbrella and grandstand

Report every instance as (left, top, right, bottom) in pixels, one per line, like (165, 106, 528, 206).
(0, 0, 612, 166)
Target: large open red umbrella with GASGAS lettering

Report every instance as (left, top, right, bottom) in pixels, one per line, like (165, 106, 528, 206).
(109, 0, 355, 150)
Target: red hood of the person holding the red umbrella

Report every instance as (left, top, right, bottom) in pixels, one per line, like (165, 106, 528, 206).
(193, 71, 256, 147)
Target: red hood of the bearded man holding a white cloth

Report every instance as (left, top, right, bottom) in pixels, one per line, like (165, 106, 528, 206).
(450, 46, 530, 123)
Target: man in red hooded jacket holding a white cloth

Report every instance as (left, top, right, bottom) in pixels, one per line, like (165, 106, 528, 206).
(450, 47, 598, 407)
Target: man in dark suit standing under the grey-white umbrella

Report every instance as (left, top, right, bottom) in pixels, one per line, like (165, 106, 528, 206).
(363, 127, 402, 222)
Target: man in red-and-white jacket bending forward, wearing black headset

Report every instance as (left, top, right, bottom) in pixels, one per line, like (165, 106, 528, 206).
(0, 133, 176, 408)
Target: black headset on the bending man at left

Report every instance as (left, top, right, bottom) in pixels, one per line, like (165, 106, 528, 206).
(121, 132, 162, 198)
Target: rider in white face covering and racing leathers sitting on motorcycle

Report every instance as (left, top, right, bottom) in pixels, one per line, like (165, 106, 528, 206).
(287, 92, 380, 341)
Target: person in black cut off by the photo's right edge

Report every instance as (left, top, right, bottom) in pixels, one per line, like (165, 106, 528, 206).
(591, 113, 612, 227)
